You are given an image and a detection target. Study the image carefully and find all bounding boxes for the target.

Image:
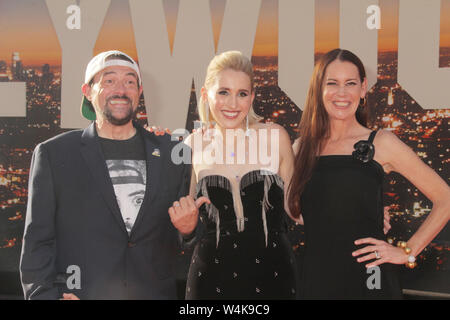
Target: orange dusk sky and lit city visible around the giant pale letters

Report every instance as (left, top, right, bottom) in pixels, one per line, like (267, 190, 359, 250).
(0, 0, 450, 293)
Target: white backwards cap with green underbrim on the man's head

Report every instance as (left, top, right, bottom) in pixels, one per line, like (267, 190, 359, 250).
(81, 50, 142, 120)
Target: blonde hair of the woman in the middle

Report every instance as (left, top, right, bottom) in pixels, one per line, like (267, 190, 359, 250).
(197, 51, 262, 124)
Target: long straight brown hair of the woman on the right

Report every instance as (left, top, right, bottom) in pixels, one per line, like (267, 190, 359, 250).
(288, 49, 367, 218)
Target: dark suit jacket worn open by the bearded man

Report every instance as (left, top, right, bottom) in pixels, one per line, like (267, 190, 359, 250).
(20, 123, 190, 299)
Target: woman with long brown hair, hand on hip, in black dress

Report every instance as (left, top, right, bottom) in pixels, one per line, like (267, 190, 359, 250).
(289, 49, 450, 299)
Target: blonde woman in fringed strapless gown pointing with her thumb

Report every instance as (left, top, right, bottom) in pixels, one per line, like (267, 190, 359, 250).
(169, 51, 296, 299)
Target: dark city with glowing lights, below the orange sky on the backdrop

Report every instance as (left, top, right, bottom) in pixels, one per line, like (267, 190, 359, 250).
(0, 50, 450, 276)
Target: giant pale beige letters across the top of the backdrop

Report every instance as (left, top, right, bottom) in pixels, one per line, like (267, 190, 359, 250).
(0, 0, 450, 129)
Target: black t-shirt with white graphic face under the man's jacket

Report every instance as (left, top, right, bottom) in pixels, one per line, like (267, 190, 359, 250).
(99, 132, 147, 233)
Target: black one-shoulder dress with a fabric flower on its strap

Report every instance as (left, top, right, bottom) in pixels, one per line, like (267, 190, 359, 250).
(300, 131, 402, 299)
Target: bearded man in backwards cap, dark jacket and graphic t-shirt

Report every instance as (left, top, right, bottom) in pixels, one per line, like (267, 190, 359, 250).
(20, 51, 190, 299)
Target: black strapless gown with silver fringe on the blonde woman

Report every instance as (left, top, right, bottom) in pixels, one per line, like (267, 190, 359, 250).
(186, 170, 297, 300)
